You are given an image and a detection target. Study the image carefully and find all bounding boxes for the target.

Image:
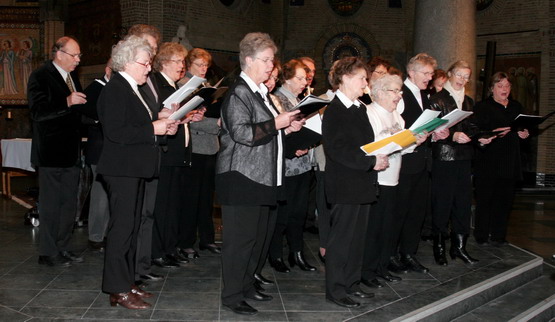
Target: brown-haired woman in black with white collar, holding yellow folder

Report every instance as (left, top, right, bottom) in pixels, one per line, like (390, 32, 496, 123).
(322, 57, 389, 308)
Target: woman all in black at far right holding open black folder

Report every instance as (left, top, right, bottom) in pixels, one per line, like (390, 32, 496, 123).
(474, 72, 529, 246)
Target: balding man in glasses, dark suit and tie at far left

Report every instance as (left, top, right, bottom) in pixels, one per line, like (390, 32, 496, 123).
(27, 37, 86, 266)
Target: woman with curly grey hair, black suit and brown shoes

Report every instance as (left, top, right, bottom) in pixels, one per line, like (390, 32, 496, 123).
(97, 36, 177, 309)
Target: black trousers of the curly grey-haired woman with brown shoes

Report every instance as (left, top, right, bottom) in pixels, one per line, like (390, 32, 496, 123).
(102, 176, 145, 293)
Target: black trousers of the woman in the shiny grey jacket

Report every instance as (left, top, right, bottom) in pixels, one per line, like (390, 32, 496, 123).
(221, 205, 270, 305)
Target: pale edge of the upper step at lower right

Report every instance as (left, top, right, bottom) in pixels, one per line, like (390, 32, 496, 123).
(392, 255, 543, 322)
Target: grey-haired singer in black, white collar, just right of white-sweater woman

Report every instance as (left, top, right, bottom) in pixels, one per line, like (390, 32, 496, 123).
(389, 53, 449, 273)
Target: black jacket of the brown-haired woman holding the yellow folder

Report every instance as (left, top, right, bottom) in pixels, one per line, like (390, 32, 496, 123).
(322, 96, 377, 204)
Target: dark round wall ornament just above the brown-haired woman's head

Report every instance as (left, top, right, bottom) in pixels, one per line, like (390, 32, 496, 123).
(322, 32, 372, 71)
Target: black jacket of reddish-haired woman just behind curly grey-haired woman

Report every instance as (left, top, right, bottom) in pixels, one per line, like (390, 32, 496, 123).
(151, 72, 192, 167)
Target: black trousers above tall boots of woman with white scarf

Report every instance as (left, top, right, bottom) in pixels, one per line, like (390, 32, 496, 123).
(432, 160, 472, 235)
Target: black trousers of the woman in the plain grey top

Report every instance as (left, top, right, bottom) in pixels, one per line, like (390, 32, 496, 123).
(179, 153, 216, 248)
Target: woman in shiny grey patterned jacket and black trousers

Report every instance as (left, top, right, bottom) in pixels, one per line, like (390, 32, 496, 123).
(216, 33, 302, 315)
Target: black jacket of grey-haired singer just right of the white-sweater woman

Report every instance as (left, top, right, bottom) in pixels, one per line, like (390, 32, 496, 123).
(400, 84, 432, 174)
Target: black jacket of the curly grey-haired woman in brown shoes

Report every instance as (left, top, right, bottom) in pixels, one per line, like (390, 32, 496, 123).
(97, 73, 159, 178)
